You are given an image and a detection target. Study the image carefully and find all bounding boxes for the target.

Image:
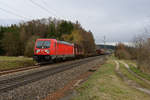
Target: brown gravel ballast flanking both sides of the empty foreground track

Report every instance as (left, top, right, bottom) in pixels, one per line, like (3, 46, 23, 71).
(0, 56, 104, 100)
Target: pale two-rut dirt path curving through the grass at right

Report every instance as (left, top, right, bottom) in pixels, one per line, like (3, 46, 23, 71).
(115, 60, 150, 95)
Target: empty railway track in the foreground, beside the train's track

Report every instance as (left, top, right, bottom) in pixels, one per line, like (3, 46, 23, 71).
(0, 56, 103, 93)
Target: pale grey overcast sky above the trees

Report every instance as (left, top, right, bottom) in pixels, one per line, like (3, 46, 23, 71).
(0, 0, 150, 43)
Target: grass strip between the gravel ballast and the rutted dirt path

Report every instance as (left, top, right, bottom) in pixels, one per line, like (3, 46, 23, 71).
(72, 59, 150, 100)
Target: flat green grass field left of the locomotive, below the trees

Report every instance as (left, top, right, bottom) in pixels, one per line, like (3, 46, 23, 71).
(0, 56, 35, 70)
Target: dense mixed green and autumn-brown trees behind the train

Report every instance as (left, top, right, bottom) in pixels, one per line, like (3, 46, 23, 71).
(0, 18, 95, 57)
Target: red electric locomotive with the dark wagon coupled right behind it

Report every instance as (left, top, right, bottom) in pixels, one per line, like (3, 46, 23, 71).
(33, 39, 83, 62)
